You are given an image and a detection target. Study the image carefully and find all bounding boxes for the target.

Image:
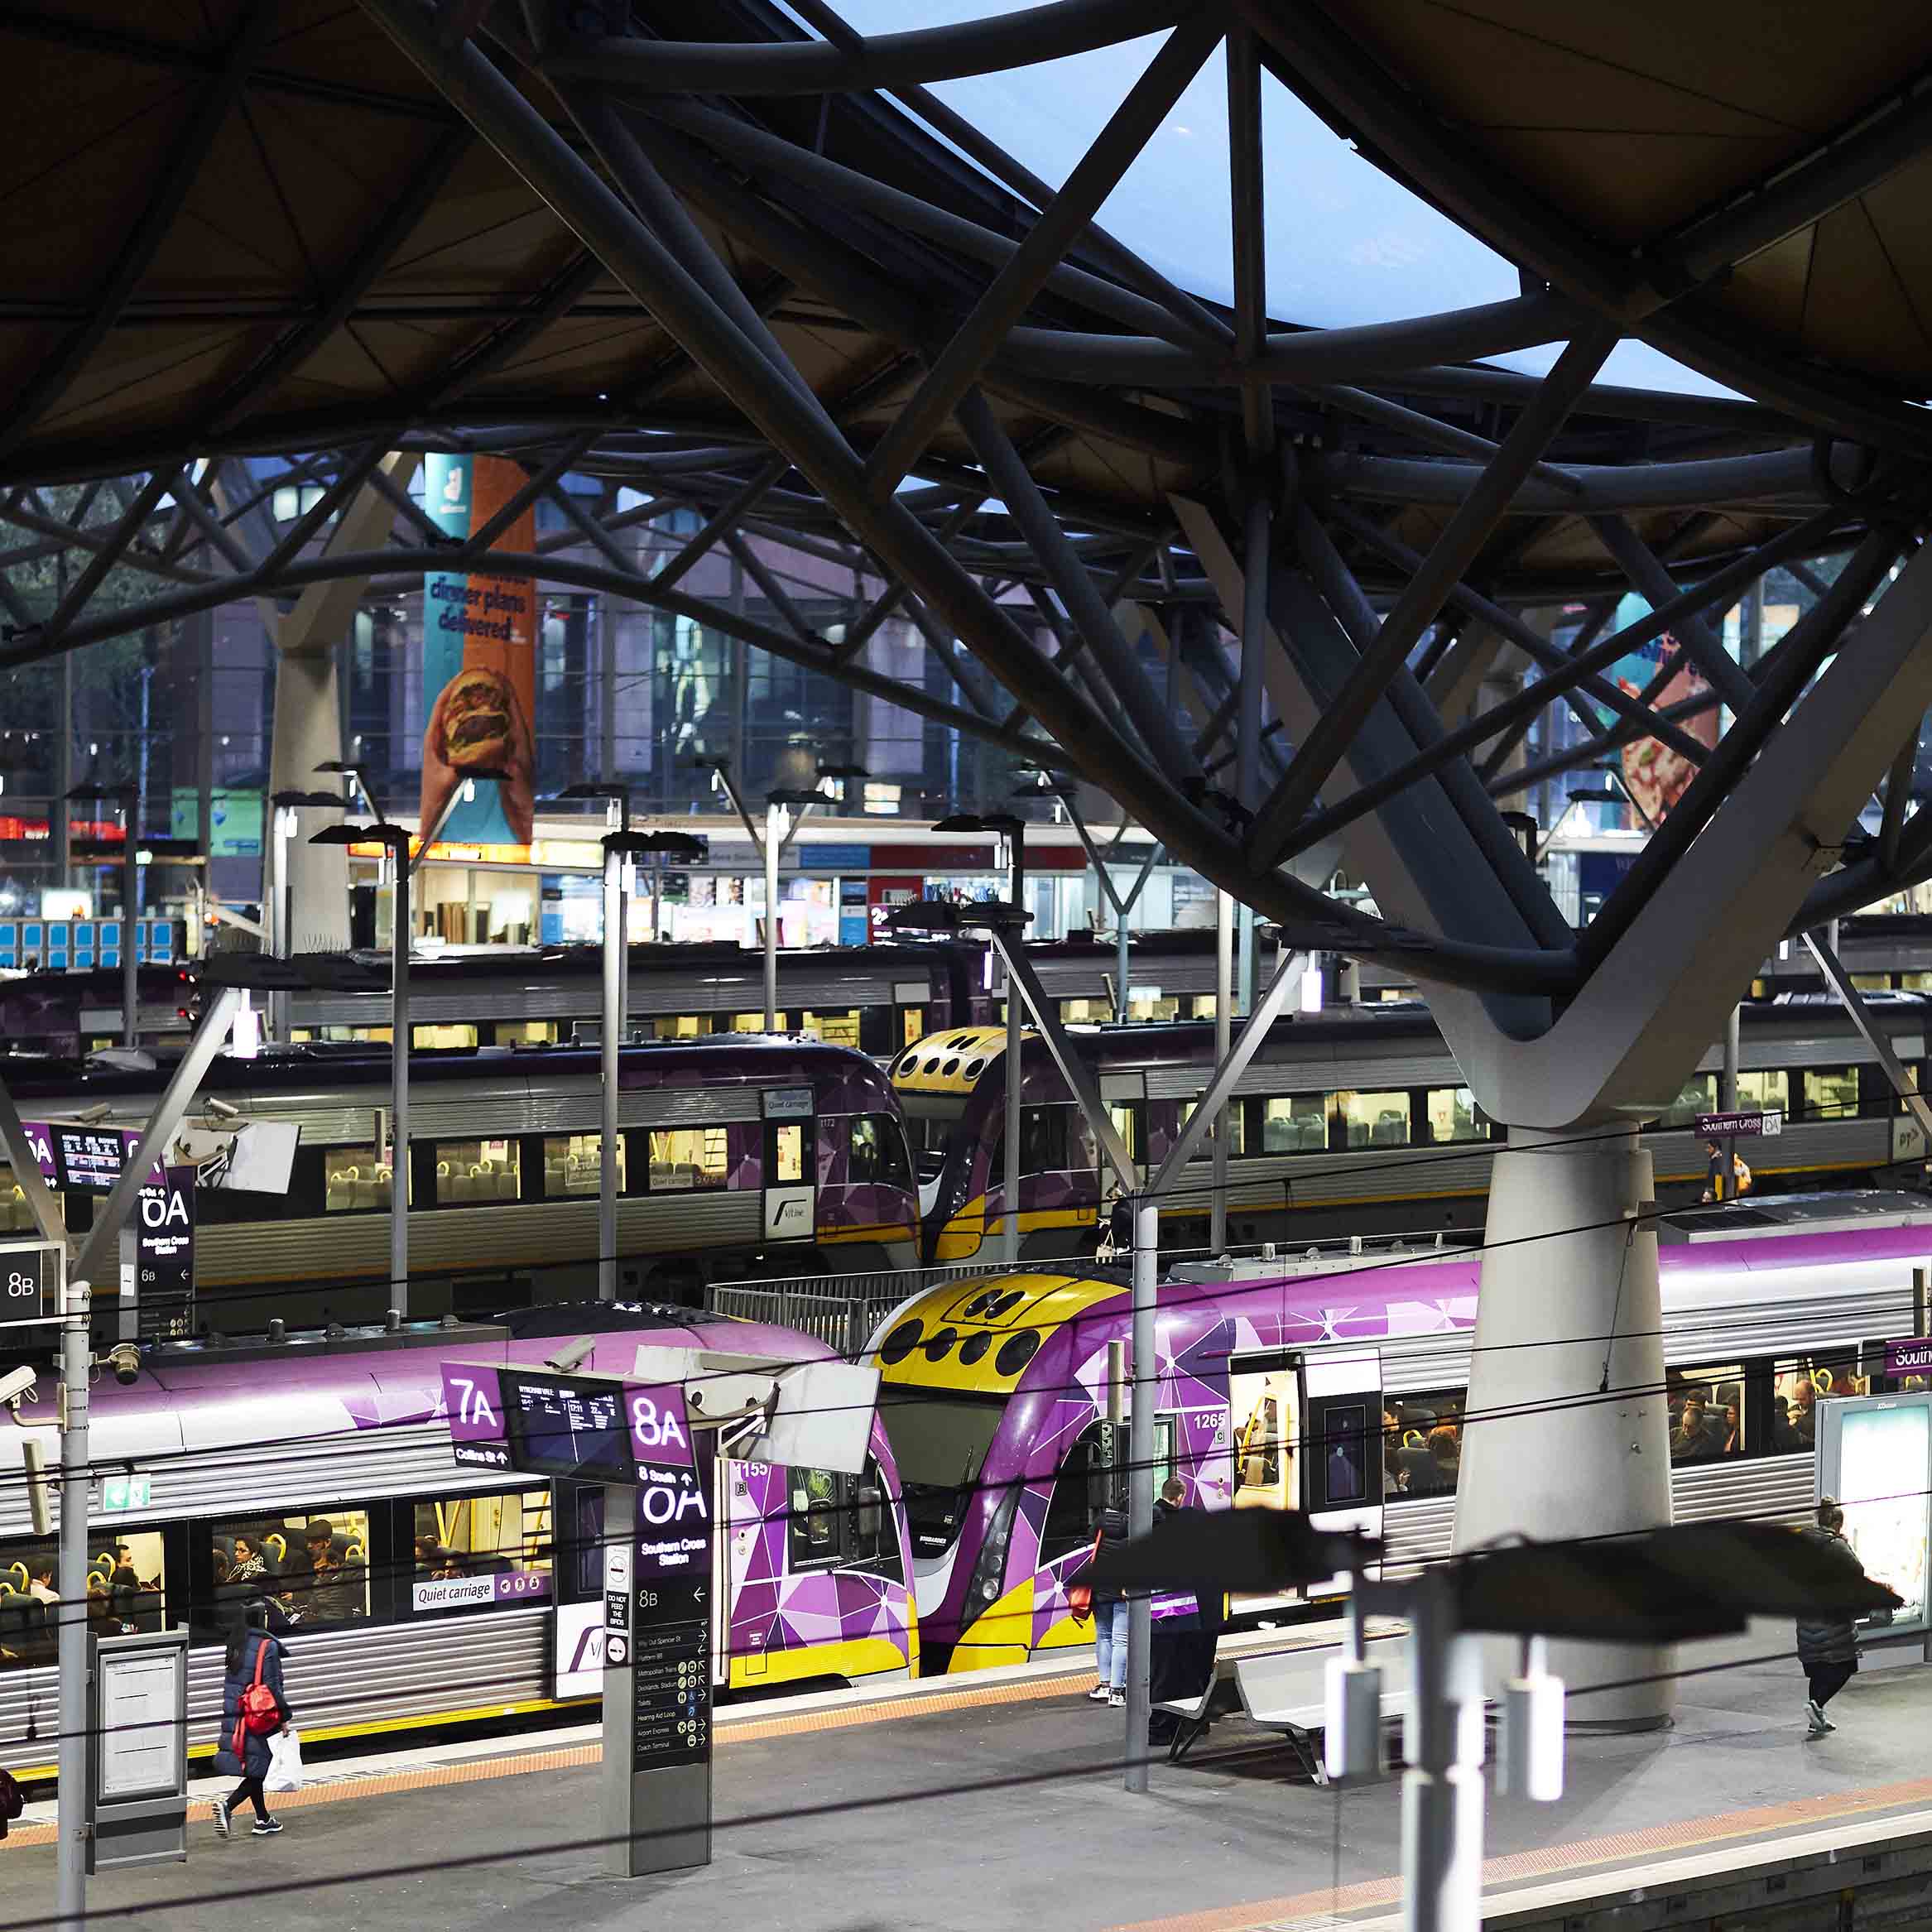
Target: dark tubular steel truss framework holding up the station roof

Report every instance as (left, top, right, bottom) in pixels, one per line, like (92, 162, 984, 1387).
(0, 0, 1932, 1030)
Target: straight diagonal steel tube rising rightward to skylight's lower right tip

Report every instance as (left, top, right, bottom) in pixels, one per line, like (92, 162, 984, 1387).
(1250, 330, 1615, 863)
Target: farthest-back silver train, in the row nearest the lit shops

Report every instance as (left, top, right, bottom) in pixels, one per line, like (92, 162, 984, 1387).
(0, 931, 1252, 1059)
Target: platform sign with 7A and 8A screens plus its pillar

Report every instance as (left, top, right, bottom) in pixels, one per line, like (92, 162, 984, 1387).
(442, 1347, 879, 1878)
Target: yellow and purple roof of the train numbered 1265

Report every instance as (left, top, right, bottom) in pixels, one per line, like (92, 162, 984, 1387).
(875, 1190, 1932, 1396)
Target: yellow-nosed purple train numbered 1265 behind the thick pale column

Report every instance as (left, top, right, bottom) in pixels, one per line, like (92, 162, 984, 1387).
(869, 1194, 1932, 1671)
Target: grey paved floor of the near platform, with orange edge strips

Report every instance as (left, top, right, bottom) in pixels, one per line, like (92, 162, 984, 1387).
(0, 1630, 1932, 1932)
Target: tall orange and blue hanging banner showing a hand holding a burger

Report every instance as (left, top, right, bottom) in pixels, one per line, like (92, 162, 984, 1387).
(421, 452, 537, 846)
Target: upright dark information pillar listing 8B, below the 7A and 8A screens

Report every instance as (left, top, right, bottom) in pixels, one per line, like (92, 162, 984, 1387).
(603, 1455, 717, 1878)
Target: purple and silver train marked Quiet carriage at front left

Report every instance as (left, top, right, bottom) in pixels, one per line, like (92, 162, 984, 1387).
(0, 1302, 920, 1777)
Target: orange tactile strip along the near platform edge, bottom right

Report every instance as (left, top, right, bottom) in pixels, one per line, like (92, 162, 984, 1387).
(1111, 1777, 1932, 1932)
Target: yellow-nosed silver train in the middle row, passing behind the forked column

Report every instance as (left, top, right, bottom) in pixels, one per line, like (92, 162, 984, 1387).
(892, 993, 1932, 1262)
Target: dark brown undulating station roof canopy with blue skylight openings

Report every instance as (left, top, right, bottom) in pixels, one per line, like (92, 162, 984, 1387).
(0, 0, 1932, 591)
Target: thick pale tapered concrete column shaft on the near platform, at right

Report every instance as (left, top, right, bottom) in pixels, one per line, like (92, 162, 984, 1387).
(1455, 1124, 1671, 1729)
